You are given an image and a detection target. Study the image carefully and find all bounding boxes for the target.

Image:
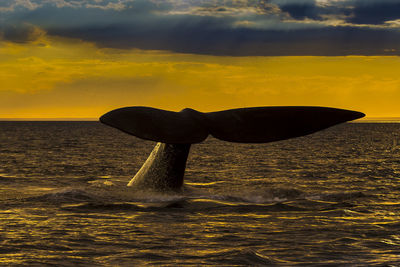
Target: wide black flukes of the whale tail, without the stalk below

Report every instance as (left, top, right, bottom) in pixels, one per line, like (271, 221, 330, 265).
(100, 106, 365, 144)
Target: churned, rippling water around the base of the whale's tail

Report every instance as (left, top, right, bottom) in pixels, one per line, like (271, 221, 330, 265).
(14, 180, 370, 213)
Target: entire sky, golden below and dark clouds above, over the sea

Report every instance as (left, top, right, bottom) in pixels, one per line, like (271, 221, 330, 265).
(0, 0, 400, 118)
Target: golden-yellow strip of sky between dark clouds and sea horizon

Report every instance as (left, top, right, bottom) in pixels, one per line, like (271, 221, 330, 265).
(0, 36, 400, 118)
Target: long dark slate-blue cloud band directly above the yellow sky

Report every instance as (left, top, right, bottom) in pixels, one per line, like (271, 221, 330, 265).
(50, 23, 400, 56)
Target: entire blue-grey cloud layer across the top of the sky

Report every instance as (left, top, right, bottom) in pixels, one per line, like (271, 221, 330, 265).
(0, 0, 400, 56)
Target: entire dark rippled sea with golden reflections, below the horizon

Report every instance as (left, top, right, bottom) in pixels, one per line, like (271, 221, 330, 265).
(0, 122, 400, 266)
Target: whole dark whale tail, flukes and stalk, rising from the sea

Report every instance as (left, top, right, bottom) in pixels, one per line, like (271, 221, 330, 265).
(100, 106, 365, 191)
